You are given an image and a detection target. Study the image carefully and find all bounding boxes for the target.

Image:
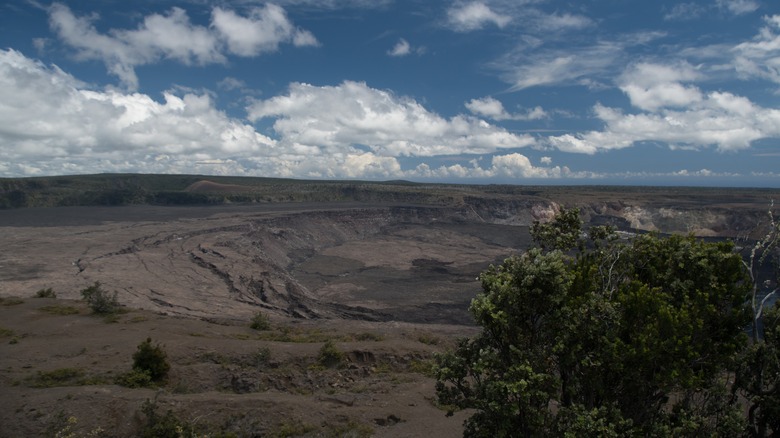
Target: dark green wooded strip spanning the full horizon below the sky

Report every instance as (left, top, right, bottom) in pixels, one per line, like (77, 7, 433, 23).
(0, 174, 780, 210)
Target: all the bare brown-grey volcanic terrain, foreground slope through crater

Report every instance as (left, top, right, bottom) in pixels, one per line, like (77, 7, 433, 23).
(0, 182, 780, 437)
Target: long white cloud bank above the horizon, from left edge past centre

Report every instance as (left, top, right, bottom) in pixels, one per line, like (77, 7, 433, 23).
(0, 50, 552, 179)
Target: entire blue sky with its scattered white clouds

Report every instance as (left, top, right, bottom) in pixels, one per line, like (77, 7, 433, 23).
(0, 0, 780, 187)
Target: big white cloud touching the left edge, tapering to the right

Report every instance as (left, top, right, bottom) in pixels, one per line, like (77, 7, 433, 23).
(0, 50, 275, 173)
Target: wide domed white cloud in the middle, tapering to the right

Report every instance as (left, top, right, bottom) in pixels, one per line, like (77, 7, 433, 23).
(248, 81, 534, 157)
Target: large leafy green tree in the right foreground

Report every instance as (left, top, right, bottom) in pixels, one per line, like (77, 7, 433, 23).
(436, 210, 756, 437)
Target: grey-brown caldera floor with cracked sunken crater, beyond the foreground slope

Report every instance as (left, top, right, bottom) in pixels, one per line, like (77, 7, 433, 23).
(0, 204, 528, 323)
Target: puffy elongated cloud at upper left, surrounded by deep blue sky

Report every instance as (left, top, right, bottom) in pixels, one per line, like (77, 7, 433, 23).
(48, 3, 318, 90)
